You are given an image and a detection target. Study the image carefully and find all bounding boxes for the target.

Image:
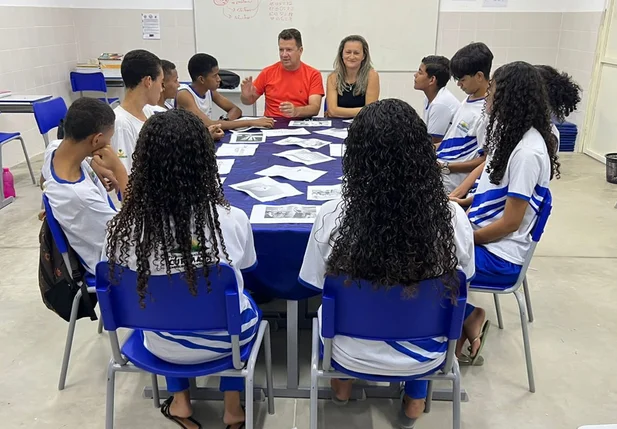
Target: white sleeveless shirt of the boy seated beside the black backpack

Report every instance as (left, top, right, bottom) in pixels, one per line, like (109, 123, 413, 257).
(43, 148, 116, 274)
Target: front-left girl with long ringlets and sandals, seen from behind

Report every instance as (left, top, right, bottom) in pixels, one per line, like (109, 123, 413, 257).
(106, 109, 261, 429)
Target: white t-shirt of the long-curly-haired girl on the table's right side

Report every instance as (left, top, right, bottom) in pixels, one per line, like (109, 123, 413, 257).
(469, 128, 551, 265)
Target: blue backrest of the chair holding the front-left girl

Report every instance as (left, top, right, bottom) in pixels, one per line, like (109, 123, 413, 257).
(96, 262, 242, 335)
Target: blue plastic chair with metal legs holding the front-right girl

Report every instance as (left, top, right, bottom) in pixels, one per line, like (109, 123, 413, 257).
(310, 272, 467, 429)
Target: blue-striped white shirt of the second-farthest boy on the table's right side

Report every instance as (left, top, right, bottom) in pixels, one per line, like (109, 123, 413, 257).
(437, 97, 485, 193)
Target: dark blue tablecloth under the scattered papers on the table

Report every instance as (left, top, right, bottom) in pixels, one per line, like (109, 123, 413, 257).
(217, 115, 349, 300)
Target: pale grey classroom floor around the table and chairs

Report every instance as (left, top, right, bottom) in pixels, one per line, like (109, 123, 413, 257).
(0, 155, 617, 429)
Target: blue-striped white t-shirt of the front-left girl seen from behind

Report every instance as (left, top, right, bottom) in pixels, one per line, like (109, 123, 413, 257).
(103, 207, 259, 365)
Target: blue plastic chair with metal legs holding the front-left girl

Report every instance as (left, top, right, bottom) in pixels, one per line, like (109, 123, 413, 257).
(96, 262, 274, 429)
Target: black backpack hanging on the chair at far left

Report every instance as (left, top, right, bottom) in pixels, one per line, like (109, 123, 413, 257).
(39, 219, 97, 322)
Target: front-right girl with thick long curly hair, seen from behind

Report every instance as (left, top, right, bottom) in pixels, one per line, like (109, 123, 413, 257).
(300, 99, 474, 427)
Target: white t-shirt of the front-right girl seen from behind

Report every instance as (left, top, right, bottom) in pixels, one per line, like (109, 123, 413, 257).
(300, 199, 475, 376)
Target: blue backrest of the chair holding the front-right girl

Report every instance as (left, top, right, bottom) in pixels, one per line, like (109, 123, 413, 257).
(321, 272, 467, 341)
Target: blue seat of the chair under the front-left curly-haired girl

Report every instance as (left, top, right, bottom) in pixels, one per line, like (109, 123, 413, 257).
(122, 331, 257, 378)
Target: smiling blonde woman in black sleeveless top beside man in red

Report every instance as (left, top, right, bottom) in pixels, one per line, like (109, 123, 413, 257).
(326, 35, 379, 118)
